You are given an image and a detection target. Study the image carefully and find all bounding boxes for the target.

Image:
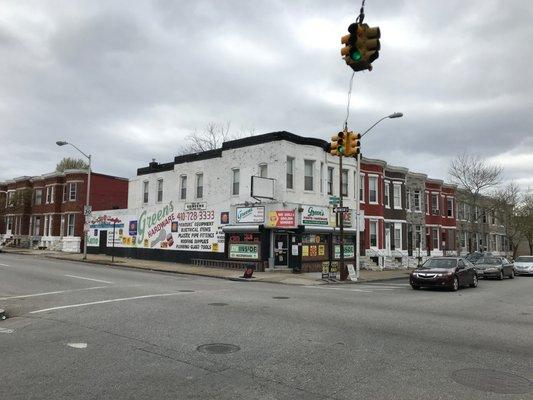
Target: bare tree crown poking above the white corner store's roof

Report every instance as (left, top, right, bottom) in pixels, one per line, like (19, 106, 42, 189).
(179, 122, 255, 154)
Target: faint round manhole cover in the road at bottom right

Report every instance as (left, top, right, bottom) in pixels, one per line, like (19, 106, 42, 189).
(451, 368, 532, 394)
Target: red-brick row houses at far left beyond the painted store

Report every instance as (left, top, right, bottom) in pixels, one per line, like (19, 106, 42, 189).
(0, 170, 128, 252)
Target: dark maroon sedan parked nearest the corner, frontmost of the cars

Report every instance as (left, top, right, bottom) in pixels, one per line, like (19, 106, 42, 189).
(409, 257, 478, 292)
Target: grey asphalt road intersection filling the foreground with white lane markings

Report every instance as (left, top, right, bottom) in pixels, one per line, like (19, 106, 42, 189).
(0, 254, 533, 400)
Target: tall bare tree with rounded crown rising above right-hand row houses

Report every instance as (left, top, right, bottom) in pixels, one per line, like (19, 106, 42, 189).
(449, 153, 503, 251)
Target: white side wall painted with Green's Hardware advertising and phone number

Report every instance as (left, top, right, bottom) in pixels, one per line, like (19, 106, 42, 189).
(87, 201, 227, 253)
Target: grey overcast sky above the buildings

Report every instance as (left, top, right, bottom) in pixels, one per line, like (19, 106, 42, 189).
(0, 0, 533, 189)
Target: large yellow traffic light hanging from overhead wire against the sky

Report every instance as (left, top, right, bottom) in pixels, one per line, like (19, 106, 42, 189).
(341, 23, 381, 71)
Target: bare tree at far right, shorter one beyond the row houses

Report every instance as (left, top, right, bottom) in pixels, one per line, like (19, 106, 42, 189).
(491, 182, 524, 258)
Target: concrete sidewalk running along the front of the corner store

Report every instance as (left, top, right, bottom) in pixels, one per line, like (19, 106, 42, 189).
(3, 248, 410, 286)
